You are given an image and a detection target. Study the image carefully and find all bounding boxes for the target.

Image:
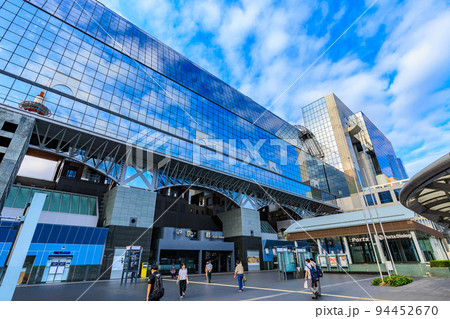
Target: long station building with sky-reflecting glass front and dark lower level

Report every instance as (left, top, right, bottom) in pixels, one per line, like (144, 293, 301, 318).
(0, 0, 350, 283)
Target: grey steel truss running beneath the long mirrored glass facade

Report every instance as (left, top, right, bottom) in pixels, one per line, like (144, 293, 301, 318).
(30, 119, 338, 218)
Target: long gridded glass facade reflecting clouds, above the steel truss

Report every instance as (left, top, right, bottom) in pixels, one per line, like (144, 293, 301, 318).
(0, 0, 348, 200)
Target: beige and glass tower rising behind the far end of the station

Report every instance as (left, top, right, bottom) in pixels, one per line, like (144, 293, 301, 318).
(302, 94, 408, 193)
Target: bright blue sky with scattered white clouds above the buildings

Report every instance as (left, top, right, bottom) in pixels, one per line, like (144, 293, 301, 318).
(98, 0, 450, 176)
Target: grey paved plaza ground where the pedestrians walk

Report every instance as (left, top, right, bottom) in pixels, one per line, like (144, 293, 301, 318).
(13, 271, 450, 301)
